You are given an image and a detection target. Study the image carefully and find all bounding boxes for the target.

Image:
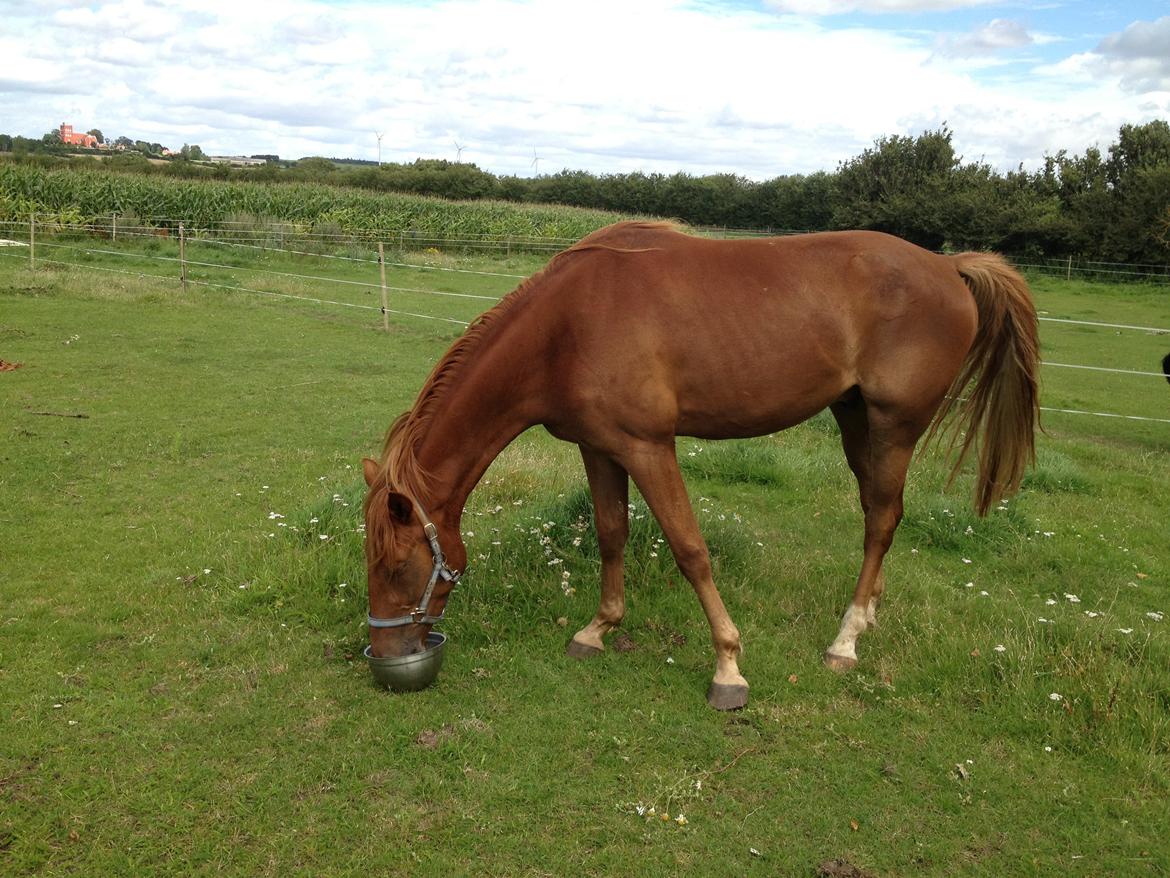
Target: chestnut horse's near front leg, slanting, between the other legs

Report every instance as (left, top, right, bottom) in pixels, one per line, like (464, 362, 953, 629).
(622, 440, 748, 711)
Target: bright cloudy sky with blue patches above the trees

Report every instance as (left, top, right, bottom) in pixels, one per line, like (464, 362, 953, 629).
(0, 0, 1170, 180)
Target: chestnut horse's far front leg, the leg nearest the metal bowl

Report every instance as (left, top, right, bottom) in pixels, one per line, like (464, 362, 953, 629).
(565, 447, 629, 658)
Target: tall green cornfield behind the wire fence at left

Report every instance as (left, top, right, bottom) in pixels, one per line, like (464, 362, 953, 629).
(0, 163, 621, 240)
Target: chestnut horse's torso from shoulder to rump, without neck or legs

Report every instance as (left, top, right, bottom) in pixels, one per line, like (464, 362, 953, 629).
(538, 224, 976, 437)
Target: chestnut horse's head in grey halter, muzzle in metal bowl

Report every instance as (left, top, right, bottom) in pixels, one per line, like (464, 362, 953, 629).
(363, 459, 463, 656)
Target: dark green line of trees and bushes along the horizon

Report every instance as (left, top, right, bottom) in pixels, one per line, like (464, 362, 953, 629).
(0, 121, 1170, 265)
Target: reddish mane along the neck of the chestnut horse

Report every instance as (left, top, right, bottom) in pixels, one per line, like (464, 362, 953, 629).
(381, 221, 676, 499)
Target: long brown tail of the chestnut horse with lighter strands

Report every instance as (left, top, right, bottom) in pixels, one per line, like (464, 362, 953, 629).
(930, 253, 1040, 515)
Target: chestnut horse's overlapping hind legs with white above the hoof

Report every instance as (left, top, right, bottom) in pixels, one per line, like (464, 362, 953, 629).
(825, 400, 924, 671)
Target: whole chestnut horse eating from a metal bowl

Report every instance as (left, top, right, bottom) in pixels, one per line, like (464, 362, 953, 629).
(365, 222, 1038, 709)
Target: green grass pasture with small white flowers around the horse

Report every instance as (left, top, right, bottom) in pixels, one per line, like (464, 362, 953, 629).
(0, 240, 1170, 876)
